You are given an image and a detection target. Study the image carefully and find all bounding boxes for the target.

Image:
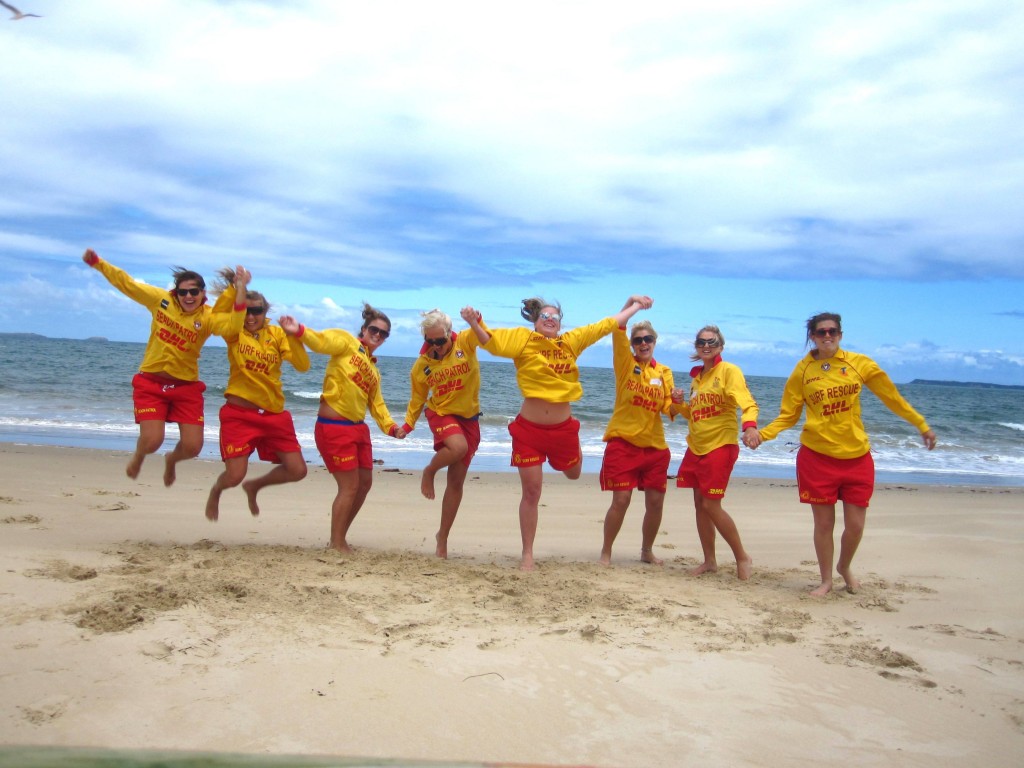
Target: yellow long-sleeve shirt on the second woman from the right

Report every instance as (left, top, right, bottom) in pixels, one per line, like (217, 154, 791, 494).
(679, 357, 758, 456)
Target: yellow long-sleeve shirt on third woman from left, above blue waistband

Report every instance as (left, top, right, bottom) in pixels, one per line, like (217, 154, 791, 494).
(296, 326, 396, 434)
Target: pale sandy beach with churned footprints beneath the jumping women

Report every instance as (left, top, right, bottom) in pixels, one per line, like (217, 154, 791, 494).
(0, 444, 1024, 768)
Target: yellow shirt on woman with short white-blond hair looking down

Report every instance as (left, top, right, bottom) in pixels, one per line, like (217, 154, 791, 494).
(403, 331, 480, 432)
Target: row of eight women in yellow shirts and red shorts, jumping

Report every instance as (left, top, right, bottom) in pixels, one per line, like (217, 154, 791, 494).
(82, 250, 936, 595)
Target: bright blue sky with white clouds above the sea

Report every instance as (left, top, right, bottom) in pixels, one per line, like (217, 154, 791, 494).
(0, 0, 1024, 384)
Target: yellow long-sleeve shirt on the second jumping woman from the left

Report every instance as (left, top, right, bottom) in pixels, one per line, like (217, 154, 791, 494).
(224, 323, 309, 414)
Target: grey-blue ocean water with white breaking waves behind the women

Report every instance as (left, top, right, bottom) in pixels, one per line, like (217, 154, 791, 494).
(0, 335, 1024, 485)
